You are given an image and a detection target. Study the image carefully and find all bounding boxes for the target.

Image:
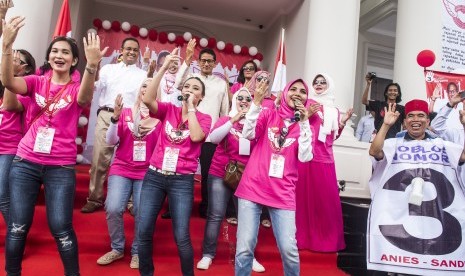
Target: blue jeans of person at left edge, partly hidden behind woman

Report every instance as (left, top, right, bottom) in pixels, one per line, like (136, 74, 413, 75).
(0, 154, 15, 225)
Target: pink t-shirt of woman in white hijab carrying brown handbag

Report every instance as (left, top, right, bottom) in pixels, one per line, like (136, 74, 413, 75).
(208, 116, 256, 178)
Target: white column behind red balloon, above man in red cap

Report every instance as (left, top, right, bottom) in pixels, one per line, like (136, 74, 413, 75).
(394, 0, 443, 104)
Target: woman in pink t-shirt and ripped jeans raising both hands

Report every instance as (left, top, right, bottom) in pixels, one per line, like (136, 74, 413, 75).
(1, 16, 106, 275)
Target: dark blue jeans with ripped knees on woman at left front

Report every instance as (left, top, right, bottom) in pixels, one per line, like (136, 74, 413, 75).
(5, 156, 79, 276)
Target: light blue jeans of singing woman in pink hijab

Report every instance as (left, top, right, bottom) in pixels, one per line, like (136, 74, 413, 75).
(234, 198, 300, 276)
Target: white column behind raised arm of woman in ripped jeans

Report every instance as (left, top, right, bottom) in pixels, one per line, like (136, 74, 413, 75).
(6, 0, 56, 66)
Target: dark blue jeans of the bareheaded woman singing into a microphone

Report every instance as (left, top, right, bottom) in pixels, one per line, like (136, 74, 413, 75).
(138, 169, 194, 276)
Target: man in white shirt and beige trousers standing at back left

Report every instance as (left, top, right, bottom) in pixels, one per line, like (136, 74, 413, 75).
(81, 37, 147, 213)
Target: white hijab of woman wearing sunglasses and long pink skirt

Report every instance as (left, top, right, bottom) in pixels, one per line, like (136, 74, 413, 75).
(309, 73, 339, 142)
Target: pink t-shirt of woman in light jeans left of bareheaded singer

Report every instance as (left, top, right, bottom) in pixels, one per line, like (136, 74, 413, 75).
(109, 108, 160, 180)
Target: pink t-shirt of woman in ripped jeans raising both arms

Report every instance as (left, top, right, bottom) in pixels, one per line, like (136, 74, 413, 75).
(16, 75, 82, 165)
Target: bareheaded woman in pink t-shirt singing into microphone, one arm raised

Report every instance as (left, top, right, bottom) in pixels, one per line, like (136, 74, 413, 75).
(138, 49, 211, 275)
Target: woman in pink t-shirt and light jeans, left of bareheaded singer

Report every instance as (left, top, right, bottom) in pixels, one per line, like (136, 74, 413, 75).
(97, 78, 160, 268)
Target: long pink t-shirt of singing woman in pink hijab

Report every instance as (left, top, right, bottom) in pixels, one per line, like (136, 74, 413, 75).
(235, 109, 300, 210)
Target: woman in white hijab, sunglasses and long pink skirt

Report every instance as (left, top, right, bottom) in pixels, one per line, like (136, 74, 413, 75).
(296, 74, 352, 252)
